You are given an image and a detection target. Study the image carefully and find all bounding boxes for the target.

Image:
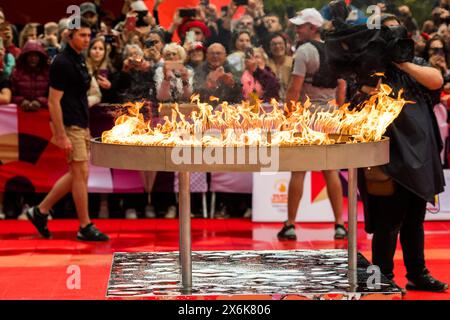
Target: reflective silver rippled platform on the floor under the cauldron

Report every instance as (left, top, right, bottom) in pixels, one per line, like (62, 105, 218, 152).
(107, 250, 402, 300)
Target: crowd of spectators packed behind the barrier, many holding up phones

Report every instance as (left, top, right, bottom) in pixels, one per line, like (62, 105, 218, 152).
(0, 0, 450, 217)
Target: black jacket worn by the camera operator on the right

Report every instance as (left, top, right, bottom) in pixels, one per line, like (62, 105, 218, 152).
(359, 58, 445, 233)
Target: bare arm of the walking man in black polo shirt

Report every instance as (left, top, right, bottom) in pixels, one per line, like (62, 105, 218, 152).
(48, 87, 72, 151)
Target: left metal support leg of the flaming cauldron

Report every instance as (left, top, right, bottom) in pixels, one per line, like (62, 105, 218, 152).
(179, 172, 192, 294)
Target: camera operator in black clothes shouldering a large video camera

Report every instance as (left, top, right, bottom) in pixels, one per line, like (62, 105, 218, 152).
(326, 14, 448, 292)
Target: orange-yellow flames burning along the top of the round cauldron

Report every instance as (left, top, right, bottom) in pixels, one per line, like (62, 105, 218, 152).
(102, 84, 409, 147)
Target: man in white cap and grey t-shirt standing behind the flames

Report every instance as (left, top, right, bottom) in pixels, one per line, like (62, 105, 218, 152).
(278, 9, 347, 240)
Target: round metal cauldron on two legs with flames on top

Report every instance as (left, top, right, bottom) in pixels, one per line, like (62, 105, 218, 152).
(91, 86, 407, 292)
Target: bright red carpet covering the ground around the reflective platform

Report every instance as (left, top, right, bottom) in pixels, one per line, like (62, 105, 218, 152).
(0, 219, 450, 300)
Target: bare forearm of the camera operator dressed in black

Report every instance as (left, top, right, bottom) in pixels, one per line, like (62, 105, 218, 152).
(395, 62, 444, 90)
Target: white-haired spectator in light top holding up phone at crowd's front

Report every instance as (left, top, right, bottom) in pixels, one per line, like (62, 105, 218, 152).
(154, 43, 193, 102)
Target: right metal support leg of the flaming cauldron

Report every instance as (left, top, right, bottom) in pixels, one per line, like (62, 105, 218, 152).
(348, 169, 358, 289)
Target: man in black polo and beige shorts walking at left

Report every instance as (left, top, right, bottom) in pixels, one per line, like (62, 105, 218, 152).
(27, 18, 109, 241)
